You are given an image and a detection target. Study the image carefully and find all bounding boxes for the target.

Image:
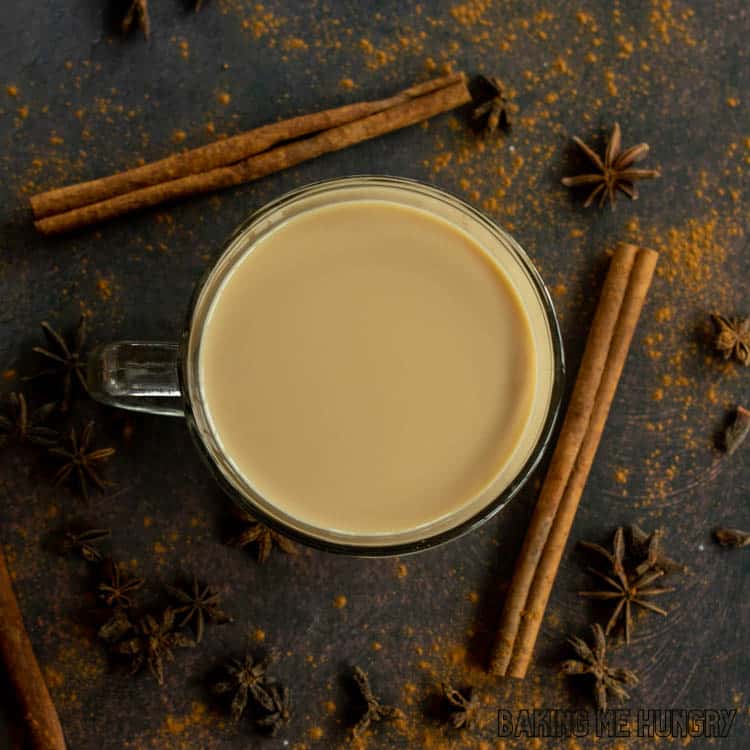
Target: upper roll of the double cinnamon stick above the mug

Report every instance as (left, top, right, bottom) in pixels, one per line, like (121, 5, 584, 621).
(31, 73, 463, 219)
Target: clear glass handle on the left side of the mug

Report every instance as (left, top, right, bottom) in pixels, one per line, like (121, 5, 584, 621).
(87, 341, 185, 417)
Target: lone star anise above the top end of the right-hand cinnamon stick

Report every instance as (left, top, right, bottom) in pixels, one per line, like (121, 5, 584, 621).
(562, 123, 660, 208)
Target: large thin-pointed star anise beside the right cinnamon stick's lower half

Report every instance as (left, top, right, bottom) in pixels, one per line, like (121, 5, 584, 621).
(578, 527, 674, 643)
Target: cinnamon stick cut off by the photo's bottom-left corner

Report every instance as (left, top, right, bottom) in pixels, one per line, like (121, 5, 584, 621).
(0, 548, 65, 750)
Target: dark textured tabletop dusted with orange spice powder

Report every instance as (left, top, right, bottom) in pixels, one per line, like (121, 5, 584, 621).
(0, 0, 750, 750)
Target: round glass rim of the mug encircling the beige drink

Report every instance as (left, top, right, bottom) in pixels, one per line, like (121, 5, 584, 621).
(179, 175, 565, 557)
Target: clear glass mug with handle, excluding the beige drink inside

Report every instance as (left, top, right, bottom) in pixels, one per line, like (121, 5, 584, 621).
(88, 176, 564, 556)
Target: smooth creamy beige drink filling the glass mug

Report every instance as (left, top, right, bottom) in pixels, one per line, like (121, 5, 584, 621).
(199, 200, 537, 534)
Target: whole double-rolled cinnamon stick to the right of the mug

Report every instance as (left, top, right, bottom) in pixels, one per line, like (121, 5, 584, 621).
(490, 243, 657, 677)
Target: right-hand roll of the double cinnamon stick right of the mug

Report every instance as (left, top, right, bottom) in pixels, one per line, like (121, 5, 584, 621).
(508, 245, 658, 678)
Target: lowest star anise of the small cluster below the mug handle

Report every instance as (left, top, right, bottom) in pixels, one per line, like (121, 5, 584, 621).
(112, 608, 195, 685)
